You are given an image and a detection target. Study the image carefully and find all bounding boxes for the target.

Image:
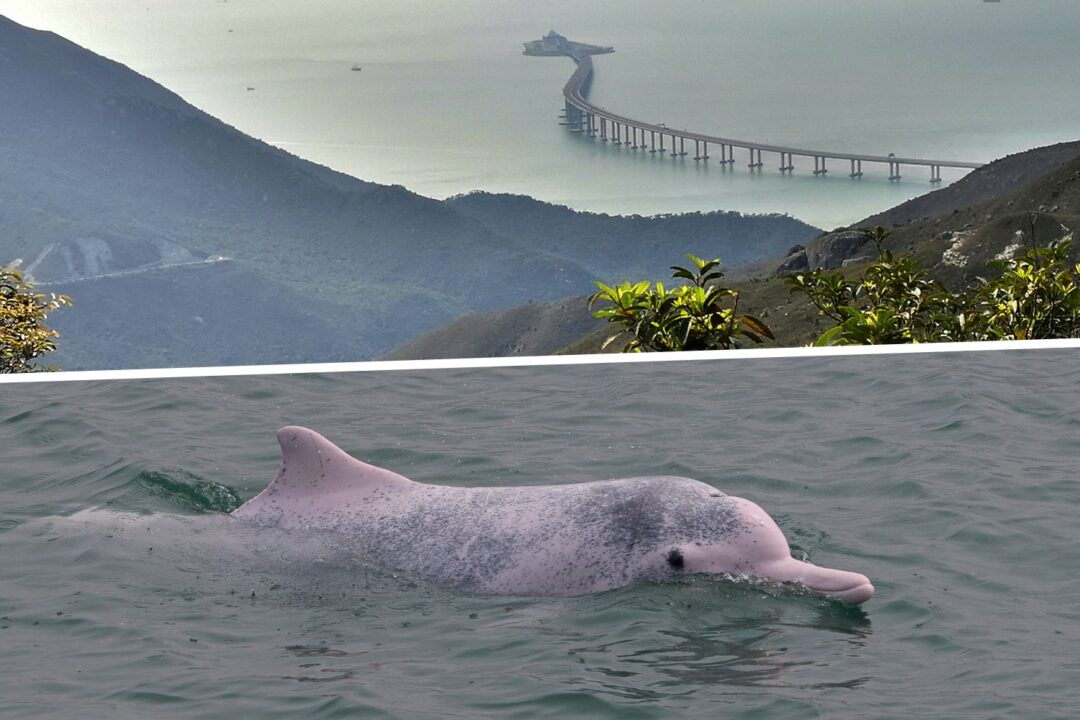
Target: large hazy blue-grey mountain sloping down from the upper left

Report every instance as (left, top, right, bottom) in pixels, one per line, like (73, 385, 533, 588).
(0, 16, 818, 369)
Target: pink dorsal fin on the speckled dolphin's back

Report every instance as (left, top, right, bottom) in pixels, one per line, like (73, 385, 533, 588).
(233, 425, 413, 517)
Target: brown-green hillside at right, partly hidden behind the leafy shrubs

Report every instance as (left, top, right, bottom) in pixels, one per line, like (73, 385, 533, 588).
(391, 141, 1080, 359)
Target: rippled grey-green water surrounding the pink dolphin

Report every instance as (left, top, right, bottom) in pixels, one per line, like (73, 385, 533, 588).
(0, 350, 1080, 718)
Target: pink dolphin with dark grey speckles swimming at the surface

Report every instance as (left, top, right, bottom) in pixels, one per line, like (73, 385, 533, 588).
(232, 426, 874, 604)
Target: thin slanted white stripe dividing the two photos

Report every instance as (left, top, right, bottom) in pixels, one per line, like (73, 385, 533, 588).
(0, 340, 1080, 384)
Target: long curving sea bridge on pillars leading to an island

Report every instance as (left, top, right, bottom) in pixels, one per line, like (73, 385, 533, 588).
(525, 30, 984, 184)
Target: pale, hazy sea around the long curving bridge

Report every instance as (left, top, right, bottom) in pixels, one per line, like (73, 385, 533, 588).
(0, 0, 1080, 228)
